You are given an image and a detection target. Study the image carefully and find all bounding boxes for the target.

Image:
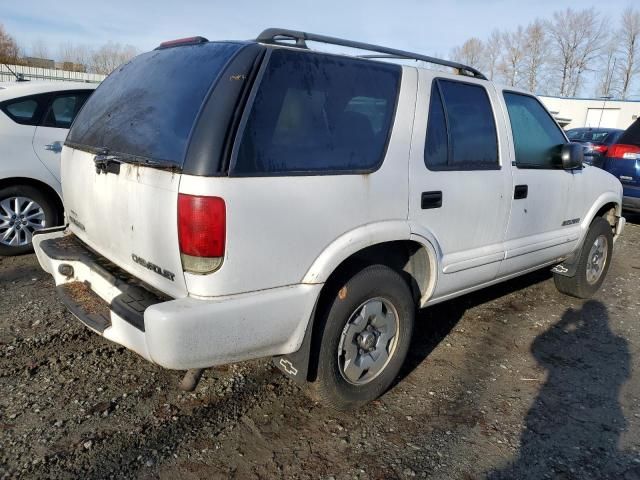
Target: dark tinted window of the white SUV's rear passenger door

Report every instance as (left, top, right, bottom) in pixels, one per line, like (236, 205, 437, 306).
(424, 79, 500, 170)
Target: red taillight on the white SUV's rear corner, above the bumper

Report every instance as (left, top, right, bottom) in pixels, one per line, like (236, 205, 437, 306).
(178, 193, 227, 273)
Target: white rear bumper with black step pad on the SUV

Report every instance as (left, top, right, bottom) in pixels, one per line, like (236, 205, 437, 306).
(33, 229, 322, 369)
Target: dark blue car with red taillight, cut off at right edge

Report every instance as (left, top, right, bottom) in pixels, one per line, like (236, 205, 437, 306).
(602, 120, 640, 213)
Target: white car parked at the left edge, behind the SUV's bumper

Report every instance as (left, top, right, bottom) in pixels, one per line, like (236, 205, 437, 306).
(0, 82, 95, 255)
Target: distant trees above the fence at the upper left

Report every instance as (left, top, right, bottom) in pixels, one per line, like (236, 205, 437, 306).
(0, 24, 139, 75)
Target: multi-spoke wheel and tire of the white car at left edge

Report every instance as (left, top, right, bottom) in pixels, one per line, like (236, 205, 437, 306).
(0, 185, 60, 256)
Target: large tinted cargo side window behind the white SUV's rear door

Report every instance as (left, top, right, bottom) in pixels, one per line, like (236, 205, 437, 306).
(232, 49, 401, 175)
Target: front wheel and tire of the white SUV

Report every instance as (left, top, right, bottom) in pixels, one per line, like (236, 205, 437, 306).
(553, 217, 613, 298)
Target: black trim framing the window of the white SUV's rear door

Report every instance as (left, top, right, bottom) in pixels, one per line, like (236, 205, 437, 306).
(422, 77, 502, 172)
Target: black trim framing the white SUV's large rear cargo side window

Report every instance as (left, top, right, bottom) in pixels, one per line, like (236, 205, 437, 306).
(229, 45, 403, 178)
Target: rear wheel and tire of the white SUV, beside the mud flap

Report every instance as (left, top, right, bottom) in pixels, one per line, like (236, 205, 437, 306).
(308, 265, 415, 410)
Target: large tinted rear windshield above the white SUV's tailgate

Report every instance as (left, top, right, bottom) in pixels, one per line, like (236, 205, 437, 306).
(67, 42, 243, 168)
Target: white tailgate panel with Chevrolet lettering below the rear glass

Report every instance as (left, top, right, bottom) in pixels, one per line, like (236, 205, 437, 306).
(62, 147, 187, 298)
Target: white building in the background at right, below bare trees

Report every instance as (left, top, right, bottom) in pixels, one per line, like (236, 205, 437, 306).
(538, 96, 640, 130)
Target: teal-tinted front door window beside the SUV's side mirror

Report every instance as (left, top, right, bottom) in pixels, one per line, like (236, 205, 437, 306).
(504, 92, 566, 168)
